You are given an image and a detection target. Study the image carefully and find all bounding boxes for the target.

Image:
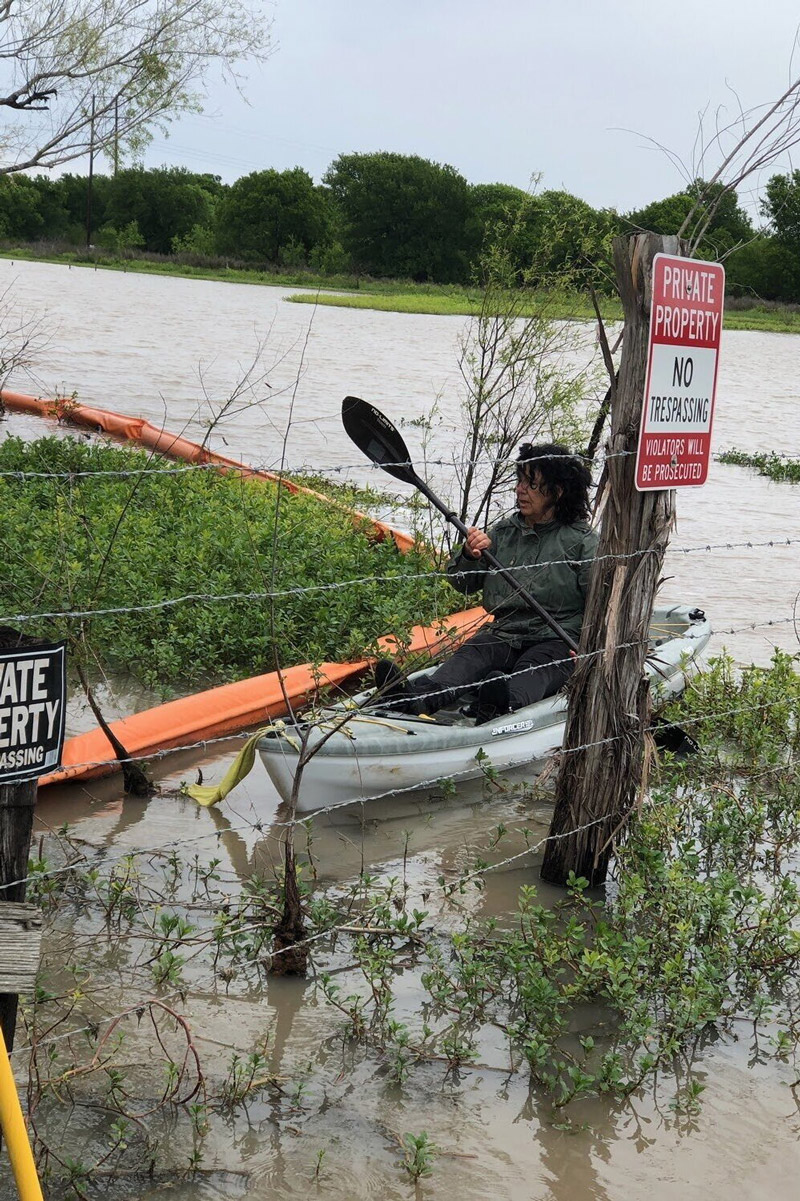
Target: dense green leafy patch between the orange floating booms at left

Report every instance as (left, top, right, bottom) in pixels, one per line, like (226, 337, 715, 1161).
(0, 438, 460, 686)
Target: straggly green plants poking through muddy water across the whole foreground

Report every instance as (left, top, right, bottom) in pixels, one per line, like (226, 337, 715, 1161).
(10, 652, 800, 1196)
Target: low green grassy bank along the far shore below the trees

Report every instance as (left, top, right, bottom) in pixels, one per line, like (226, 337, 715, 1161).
(0, 246, 800, 334)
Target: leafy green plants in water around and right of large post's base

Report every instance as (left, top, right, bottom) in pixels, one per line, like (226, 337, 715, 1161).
(312, 652, 800, 1110)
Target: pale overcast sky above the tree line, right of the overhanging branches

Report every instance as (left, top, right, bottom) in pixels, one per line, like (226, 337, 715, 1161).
(139, 0, 800, 211)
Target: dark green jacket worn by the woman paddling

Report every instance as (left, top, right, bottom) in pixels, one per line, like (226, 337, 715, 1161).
(447, 513, 597, 646)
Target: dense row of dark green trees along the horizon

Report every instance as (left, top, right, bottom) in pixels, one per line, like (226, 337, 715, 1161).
(0, 151, 800, 301)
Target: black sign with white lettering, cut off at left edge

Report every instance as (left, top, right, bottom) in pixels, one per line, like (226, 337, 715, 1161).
(0, 643, 66, 783)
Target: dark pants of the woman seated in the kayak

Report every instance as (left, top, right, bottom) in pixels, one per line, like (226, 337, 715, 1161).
(406, 626, 575, 713)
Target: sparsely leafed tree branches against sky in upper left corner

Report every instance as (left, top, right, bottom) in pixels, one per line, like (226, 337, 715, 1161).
(0, 0, 270, 174)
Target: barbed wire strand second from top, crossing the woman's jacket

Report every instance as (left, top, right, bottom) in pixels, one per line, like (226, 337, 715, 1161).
(6, 538, 800, 625)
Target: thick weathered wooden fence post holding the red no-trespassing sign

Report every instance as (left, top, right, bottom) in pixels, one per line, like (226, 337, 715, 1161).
(542, 233, 681, 885)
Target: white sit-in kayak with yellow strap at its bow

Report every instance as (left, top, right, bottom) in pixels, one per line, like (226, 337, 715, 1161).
(258, 605, 711, 813)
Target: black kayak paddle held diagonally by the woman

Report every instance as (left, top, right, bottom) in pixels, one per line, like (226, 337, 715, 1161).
(341, 396, 578, 651)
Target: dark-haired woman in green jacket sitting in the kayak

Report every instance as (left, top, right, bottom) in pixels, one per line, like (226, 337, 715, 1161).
(375, 442, 597, 722)
